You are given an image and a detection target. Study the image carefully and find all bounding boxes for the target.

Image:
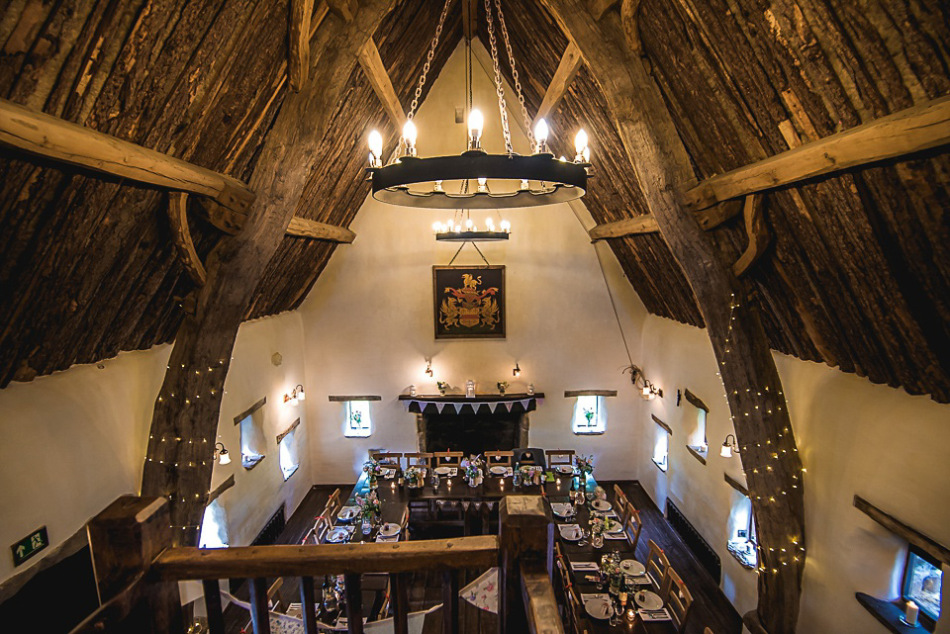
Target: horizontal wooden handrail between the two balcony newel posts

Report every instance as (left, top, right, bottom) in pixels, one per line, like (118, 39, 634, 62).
(151, 535, 498, 580)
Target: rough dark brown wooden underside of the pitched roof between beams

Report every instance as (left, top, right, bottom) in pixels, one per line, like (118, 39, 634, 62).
(0, 0, 950, 402)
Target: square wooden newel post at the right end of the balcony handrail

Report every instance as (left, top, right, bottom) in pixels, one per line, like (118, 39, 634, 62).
(498, 495, 554, 634)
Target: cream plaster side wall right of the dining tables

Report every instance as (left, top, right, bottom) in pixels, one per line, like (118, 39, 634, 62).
(637, 316, 950, 632)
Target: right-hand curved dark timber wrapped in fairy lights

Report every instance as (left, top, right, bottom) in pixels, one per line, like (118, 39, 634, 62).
(543, 0, 805, 634)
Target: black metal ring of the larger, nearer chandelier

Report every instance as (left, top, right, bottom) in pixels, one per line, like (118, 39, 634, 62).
(367, 150, 589, 209)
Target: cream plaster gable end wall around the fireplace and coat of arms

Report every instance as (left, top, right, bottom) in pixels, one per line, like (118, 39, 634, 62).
(301, 43, 645, 482)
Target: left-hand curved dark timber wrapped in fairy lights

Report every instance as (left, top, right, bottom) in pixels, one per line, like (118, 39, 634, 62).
(142, 0, 394, 545)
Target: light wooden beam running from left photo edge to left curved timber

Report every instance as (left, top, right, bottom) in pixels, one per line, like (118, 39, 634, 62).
(0, 99, 255, 211)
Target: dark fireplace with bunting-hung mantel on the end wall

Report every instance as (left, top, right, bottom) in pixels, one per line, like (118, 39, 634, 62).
(400, 394, 544, 455)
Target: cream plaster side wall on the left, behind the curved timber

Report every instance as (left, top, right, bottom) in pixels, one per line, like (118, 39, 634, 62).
(0, 313, 311, 582)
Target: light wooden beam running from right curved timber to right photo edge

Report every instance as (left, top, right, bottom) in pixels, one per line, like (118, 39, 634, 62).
(683, 97, 950, 209)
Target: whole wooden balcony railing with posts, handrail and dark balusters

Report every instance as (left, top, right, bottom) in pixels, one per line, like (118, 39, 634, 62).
(73, 496, 563, 634)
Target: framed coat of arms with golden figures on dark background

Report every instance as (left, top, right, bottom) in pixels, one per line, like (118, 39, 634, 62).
(432, 266, 505, 339)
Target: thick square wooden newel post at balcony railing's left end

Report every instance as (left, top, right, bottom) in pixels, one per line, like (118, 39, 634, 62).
(86, 495, 184, 633)
